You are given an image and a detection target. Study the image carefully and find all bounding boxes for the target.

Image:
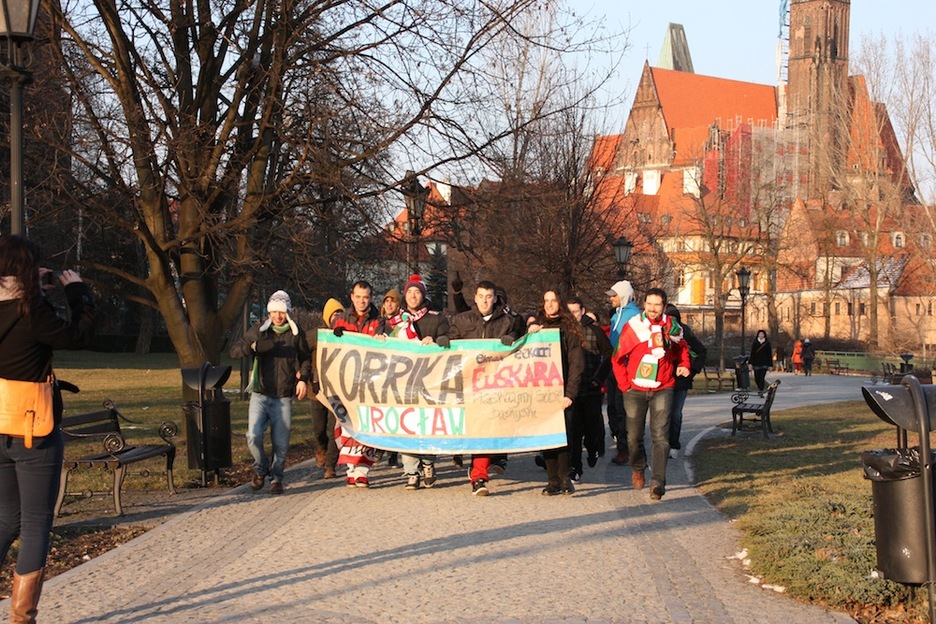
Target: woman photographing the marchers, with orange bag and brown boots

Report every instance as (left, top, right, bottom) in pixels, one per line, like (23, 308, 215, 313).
(0, 236, 94, 622)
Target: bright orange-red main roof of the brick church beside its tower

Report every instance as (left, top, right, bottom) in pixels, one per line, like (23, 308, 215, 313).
(650, 67, 777, 129)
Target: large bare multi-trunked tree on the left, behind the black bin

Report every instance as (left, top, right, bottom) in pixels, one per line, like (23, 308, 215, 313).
(33, 0, 612, 366)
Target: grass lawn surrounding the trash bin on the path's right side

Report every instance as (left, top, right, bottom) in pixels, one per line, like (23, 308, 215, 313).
(693, 402, 926, 622)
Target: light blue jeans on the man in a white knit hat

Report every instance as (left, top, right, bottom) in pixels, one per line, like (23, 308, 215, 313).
(247, 392, 292, 483)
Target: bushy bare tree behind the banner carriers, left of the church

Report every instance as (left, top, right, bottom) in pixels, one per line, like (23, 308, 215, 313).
(430, 4, 628, 307)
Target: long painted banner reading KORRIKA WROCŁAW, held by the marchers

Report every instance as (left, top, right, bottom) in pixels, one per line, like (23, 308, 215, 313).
(316, 329, 566, 454)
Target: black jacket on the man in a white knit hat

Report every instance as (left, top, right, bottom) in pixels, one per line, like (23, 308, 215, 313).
(231, 321, 312, 398)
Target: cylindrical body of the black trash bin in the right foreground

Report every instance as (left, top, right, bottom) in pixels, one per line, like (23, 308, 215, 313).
(861, 447, 936, 585)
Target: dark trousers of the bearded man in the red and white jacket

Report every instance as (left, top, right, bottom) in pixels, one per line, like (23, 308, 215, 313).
(624, 388, 673, 485)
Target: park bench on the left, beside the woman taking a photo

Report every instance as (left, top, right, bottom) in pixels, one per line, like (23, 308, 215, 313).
(55, 399, 179, 516)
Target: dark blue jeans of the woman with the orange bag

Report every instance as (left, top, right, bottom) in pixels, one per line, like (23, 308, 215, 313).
(0, 427, 64, 574)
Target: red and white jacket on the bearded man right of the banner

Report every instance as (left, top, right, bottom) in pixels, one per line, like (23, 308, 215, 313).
(613, 312, 690, 392)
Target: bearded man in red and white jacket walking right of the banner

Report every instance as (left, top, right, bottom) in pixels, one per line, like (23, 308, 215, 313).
(612, 288, 690, 500)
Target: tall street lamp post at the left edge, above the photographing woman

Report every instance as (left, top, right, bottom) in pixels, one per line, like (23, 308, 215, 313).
(0, 0, 40, 236)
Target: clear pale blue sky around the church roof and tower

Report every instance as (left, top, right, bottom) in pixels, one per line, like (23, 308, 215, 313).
(584, 0, 936, 112)
